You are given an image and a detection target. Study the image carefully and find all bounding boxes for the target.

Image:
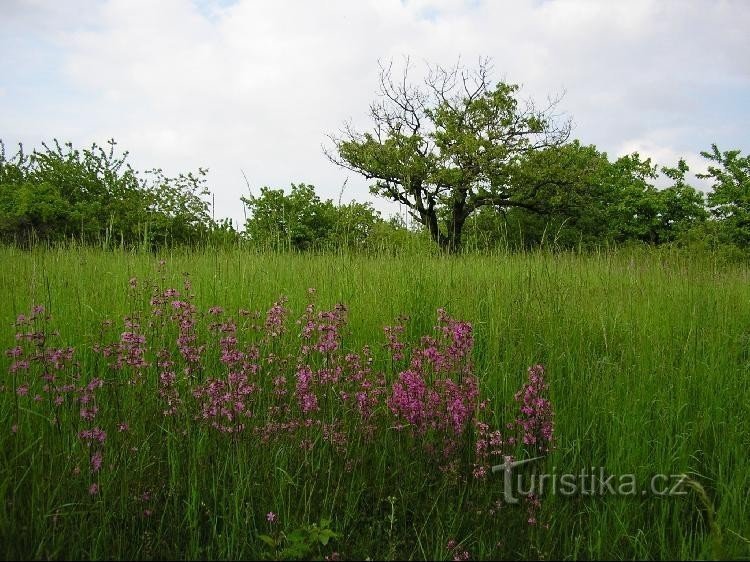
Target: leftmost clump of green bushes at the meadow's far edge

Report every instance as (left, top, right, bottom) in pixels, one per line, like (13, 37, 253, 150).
(0, 140, 238, 247)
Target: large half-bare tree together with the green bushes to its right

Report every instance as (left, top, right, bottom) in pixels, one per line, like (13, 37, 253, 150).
(328, 61, 750, 251)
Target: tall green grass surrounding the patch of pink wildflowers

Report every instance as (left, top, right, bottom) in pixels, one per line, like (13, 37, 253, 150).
(0, 248, 750, 559)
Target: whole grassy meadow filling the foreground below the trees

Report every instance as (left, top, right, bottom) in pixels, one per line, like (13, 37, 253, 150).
(0, 248, 750, 560)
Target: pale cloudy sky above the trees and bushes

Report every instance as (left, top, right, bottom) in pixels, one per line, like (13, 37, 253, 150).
(0, 0, 750, 224)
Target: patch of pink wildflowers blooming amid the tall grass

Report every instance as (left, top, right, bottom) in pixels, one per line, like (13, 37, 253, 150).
(6, 272, 553, 524)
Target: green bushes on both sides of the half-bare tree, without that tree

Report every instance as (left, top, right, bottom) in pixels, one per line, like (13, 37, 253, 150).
(0, 137, 750, 251)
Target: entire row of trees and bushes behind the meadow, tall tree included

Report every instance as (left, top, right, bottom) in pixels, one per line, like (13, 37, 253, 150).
(0, 130, 750, 255)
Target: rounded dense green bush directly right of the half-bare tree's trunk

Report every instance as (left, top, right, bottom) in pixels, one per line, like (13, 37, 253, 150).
(467, 140, 708, 248)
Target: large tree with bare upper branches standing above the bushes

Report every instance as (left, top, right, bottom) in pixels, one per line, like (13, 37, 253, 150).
(326, 59, 570, 251)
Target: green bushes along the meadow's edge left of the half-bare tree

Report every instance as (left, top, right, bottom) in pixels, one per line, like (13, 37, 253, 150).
(0, 140, 406, 251)
